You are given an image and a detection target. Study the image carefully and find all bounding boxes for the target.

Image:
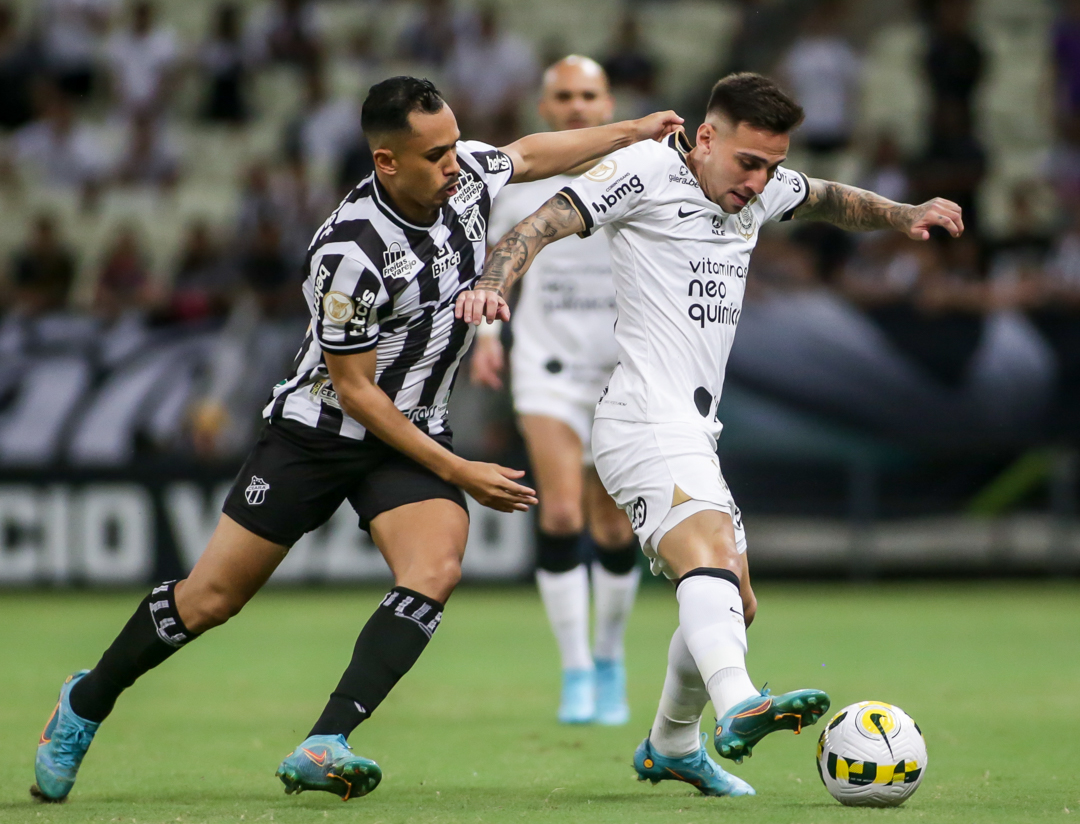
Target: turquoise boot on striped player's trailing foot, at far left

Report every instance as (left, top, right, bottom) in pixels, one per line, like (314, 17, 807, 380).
(30, 670, 102, 802)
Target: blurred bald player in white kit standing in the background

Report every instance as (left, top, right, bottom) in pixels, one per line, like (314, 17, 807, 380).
(472, 55, 639, 725)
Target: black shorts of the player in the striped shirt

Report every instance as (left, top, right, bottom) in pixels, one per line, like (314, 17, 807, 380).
(221, 420, 469, 546)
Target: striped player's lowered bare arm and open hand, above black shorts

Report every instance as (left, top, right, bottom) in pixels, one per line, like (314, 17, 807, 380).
(324, 349, 537, 512)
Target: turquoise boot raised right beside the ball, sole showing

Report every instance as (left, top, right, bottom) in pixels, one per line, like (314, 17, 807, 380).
(713, 689, 829, 764)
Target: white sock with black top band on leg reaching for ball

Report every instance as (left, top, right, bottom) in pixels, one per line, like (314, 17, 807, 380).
(675, 575, 758, 718)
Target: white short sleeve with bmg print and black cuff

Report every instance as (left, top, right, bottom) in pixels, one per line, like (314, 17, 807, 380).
(561, 140, 656, 238)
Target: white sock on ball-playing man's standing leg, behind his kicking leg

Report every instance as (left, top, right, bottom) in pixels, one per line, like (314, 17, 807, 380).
(649, 629, 708, 758)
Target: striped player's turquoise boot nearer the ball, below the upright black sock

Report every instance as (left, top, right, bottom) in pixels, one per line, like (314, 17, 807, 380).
(275, 735, 382, 801)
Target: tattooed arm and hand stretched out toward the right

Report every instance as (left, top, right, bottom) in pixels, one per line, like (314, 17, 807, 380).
(793, 178, 963, 241)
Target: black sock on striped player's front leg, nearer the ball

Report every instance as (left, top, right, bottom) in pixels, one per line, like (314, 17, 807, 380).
(308, 586, 443, 738)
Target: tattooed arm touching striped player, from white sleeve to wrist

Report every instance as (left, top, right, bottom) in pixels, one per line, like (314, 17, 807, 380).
(476, 193, 585, 296)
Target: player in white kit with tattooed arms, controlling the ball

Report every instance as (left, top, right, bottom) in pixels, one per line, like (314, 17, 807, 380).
(457, 73, 963, 795)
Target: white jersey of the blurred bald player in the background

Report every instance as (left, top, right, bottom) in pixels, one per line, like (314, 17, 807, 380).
(488, 175, 619, 382)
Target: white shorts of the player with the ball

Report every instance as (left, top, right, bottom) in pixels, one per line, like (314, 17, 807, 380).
(593, 418, 746, 578)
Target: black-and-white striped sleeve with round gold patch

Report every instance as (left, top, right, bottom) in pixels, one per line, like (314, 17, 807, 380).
(311, 254, 390, 354)
